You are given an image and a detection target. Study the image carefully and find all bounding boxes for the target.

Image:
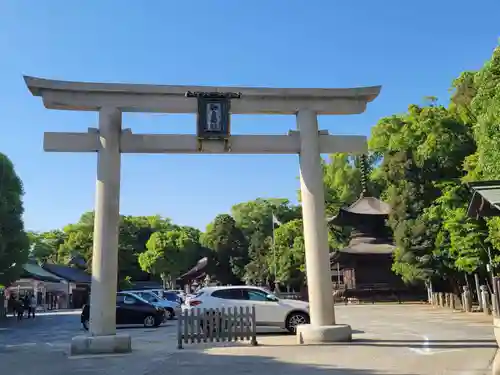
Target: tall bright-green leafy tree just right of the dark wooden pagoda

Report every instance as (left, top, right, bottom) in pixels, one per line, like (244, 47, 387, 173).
(370, 104, 475, 282)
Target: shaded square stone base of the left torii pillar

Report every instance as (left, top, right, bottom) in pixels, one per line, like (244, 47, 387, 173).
(70, 334, 132, 355)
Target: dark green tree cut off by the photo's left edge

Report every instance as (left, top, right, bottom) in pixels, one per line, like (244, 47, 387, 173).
(0, 153, 30, 285)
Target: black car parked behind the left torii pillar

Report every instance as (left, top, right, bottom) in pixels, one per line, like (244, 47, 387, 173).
(81, 293, 165, 330)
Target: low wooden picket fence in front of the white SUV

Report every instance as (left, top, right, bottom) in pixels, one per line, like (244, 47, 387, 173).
(177, 306, 257, 349)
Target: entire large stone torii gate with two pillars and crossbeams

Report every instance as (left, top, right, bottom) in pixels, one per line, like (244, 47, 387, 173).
(25, 77, 381, 354)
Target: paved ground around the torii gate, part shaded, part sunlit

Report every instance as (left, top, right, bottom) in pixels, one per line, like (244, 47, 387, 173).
(0, 305, 496, 375)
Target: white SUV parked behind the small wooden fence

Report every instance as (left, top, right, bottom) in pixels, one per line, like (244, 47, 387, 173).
(185, 285, 309, 333)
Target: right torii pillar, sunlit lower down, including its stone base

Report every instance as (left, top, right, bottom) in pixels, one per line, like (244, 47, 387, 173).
(297, 109, 352, 344)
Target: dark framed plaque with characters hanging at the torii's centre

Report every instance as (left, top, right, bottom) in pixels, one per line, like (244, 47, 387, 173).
(186, 91, 241, 152)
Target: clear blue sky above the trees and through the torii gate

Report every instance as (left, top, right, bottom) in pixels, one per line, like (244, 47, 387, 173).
(0, 0, 500, 234)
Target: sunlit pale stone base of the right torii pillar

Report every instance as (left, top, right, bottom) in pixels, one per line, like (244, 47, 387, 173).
(297, 324, 352, 345)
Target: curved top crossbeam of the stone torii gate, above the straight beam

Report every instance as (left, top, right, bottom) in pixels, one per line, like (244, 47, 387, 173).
(24, 76, 381, 115)
